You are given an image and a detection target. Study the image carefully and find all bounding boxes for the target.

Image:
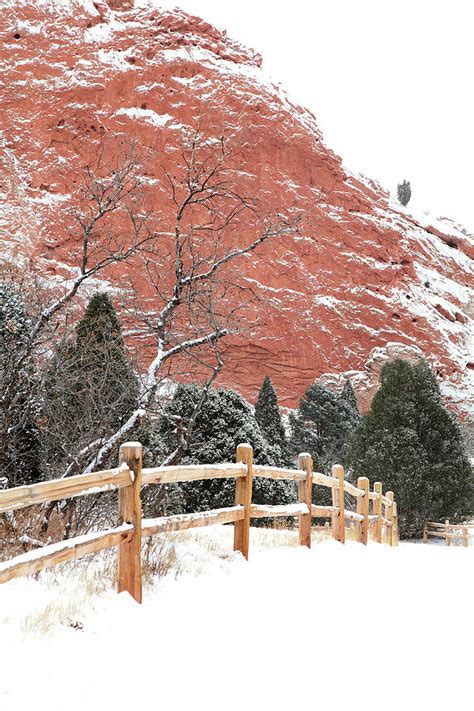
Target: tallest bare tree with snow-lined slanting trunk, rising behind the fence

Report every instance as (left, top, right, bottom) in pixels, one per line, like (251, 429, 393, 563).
(77, 132, 301, 472)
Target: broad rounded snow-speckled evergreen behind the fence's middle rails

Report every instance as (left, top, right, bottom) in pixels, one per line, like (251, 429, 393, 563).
(147, 385, 295, 515)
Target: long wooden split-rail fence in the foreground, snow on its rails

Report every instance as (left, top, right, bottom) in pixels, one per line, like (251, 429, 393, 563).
(0, 442, 398, 602)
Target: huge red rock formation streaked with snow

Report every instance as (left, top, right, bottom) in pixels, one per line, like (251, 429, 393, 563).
(0, 0, 474, 414)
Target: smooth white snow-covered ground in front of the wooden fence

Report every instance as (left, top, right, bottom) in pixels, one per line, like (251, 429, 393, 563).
(0, 526, 474, 711)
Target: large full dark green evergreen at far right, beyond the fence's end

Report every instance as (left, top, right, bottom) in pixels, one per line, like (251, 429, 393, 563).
(349, 360, 473, 536)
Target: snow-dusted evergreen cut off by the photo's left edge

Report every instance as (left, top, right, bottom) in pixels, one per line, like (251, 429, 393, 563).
(0, 281, 42, 486)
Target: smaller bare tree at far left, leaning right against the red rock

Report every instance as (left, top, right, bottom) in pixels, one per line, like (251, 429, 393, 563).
(0, 148, 154, 464)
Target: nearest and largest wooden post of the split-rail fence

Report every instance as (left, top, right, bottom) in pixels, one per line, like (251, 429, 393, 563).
(118, 442, 142, 602)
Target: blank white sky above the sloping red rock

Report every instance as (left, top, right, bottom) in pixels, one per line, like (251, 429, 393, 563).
(153, 0, 474, 232)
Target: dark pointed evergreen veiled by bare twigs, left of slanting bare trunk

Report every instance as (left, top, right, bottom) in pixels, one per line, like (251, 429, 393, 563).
(46, 293, 139, 473)
